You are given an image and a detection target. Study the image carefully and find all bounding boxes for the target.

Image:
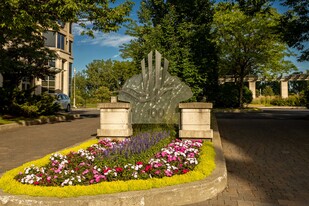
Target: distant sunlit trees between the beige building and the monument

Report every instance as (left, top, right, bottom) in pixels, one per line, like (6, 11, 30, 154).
(73, 59, 138, 105)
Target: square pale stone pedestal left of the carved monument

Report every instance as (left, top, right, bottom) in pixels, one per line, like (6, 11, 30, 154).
(97, 102, 133, 138)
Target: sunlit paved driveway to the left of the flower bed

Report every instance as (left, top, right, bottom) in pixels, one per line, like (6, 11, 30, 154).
(0, 110, 100, 174)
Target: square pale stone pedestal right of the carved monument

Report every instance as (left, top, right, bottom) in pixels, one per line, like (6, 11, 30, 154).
(179, 102, 213, 139)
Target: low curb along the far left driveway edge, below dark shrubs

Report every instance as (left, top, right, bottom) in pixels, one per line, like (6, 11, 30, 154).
(0, 114, 80, 131)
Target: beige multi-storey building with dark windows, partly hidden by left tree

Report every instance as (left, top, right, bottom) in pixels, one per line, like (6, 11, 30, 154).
(0, 21, 74, 96)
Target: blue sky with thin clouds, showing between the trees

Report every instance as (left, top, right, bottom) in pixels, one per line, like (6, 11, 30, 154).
(73, 0, 309, 71)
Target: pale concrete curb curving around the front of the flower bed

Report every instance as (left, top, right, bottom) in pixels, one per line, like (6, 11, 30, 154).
(0, 118, 227, 206)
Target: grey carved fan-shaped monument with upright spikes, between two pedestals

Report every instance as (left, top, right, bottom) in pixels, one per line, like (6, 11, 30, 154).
(118, 51, 192, 124)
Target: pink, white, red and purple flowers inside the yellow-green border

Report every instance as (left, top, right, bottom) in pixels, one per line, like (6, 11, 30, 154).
(15, 132, 202, 186)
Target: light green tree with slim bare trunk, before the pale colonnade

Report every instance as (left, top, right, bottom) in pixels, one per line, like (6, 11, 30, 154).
(214, 4, 295, 107)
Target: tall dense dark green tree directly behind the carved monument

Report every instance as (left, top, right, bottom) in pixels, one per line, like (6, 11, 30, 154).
(122, 0, 218, 100)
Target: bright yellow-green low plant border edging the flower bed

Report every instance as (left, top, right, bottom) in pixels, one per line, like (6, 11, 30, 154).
(0, 139, 215, 198)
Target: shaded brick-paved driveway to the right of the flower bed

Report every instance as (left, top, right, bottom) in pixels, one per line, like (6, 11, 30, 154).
(203, 110, 309, 206)
